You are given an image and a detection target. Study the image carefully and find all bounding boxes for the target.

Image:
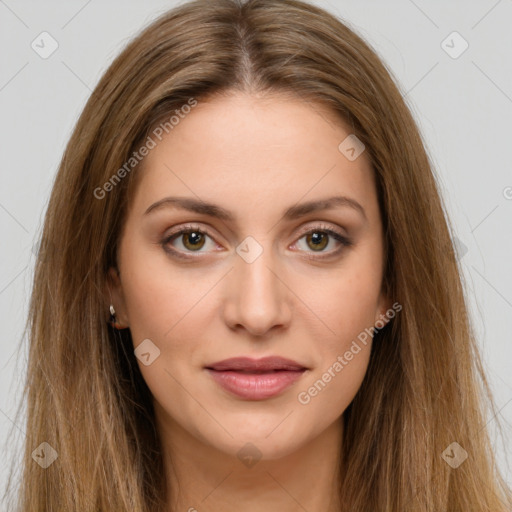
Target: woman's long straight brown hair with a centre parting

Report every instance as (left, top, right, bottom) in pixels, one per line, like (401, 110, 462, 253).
(3, 0, 512, 512)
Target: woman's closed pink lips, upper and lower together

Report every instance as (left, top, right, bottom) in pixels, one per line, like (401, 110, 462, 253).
(206, 357, 307, 400)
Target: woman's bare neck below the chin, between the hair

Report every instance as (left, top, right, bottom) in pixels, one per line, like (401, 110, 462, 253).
(159, 411, 343, 512)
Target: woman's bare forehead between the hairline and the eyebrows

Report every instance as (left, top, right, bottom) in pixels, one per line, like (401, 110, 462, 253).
(127, 93, 376, 226)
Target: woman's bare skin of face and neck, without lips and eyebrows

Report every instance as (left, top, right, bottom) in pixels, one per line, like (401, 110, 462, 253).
(109, 92, 391, 512)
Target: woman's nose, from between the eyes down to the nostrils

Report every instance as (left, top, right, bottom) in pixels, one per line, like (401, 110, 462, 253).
(223, 243, 291, 337)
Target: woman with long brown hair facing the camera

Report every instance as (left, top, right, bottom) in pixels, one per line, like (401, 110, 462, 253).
(5, 0, 512, 512)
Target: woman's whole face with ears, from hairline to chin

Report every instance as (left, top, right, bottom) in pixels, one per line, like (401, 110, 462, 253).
(110, 93, 389, 459)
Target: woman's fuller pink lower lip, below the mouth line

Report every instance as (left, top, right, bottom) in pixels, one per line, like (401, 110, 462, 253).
(208, 369, 305, 400)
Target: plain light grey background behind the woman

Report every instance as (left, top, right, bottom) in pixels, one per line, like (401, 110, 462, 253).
(0, 0, 512, 500)
